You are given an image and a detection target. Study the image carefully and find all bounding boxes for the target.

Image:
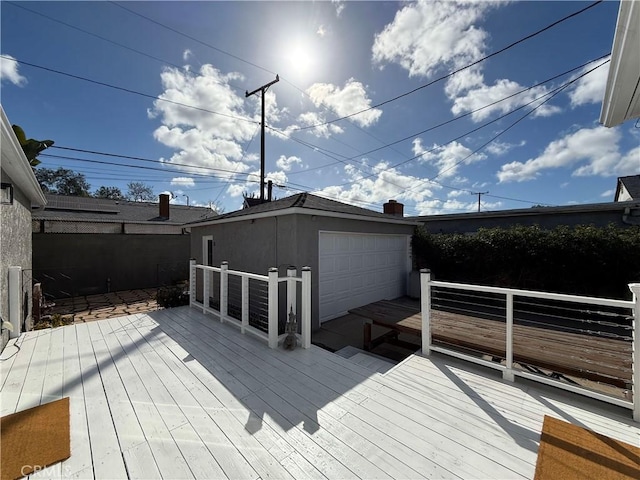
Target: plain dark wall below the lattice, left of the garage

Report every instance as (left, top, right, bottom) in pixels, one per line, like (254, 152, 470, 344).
(30, 232, 190, 298)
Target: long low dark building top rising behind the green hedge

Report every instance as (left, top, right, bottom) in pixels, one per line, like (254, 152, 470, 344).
(410, 201, 640, 233)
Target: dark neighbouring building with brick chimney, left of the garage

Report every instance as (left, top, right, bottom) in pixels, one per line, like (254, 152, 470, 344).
(30, 195, 216, 298)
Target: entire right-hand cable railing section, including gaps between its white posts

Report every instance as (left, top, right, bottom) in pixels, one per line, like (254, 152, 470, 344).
(421, 270, 640, 421)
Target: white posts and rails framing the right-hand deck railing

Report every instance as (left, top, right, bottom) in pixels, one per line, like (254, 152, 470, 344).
(420, 269, 640, 422)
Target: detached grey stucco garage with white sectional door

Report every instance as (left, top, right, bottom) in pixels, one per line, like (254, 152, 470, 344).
(190, 193, 417, 329)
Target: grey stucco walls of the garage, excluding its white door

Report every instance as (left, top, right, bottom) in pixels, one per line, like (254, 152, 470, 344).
(191, 215, 414, 329)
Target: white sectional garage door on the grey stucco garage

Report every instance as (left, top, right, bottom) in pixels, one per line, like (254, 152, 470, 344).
(318, 232, 410, 322)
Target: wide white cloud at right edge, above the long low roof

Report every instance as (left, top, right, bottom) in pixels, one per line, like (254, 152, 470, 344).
(497, 126, 640, 183)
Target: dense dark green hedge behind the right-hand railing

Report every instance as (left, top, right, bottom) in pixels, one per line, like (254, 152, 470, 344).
(412, 225, 640, 299)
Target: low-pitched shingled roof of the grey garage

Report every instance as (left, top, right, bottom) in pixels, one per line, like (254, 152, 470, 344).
(190, 193, 416, 227)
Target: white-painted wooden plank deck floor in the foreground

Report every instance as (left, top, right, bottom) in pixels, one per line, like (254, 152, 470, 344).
(0, 307, 640, 479)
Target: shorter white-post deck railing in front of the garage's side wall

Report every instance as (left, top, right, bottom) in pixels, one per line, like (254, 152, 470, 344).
(189, 260, 311, 348)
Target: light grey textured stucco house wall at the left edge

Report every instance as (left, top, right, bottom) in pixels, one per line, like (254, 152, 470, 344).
(0, 171, 32, 348)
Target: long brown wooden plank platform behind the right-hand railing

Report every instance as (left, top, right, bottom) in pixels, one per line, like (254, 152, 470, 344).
(349, 300, 632, 388)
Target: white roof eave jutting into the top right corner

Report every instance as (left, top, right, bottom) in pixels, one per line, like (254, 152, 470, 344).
(600, 1, 640, 127)
